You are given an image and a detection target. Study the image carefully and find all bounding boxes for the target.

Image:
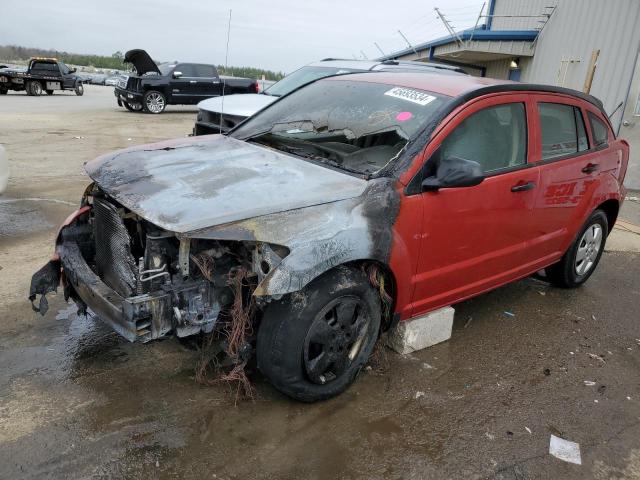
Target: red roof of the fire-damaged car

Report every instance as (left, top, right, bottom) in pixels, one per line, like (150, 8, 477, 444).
(325, 72, 607, 113)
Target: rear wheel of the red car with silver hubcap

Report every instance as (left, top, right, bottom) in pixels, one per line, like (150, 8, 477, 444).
(545, 210, 609, 288)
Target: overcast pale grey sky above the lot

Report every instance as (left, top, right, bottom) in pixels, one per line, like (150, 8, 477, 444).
(0, 0, 483, 73)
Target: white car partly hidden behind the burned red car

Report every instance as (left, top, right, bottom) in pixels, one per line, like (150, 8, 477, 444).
(193, 58, 466, 135)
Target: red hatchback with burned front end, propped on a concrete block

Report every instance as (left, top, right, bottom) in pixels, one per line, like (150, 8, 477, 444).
(30, 73, 629, 401)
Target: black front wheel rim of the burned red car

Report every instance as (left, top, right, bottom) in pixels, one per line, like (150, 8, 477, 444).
(303, 296, 371, 385)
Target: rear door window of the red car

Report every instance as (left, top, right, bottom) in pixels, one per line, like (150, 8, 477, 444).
(538, 103, 589, 160)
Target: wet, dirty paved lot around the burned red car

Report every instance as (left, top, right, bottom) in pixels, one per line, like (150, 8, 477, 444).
(0, 86, 640, 479)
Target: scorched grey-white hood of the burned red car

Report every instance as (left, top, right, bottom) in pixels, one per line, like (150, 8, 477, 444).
(85, 135, 367, 233)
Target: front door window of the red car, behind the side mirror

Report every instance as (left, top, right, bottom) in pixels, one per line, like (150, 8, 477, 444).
(440, 103, 527, 173)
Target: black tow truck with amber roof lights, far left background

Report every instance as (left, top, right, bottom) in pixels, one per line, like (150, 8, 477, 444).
(0, 58, 84, 95)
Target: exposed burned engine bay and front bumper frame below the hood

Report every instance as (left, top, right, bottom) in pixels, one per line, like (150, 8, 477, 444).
(48, 185, 287, 348)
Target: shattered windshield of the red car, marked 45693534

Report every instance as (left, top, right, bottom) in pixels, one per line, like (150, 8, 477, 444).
(230, 78, 448, 175)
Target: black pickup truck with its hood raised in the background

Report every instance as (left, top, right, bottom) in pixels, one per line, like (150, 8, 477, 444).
(114, 49, 258, 113)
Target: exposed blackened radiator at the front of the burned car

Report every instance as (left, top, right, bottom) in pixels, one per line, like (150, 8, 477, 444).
(93, 198, 137, 297)
